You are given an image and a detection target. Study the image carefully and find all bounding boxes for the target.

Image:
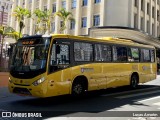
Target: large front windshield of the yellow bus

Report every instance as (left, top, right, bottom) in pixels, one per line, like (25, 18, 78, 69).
(11, 37, 50, 78)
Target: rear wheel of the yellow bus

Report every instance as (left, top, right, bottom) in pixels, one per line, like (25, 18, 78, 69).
(130, 74, 139, 89)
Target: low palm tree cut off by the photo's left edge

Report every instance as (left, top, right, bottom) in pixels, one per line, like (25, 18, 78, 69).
(0, 26, 21, 60)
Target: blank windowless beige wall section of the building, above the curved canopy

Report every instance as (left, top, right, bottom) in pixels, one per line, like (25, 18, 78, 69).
(105, 0, 129, 27)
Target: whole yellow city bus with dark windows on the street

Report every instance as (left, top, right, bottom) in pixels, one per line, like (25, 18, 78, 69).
(9, 34, 157, 97)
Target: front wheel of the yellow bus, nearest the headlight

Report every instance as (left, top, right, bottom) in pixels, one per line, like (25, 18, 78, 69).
(72, 79, 86, 96)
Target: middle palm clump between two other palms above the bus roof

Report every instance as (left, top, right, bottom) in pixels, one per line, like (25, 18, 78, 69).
(34, 9, 54, 34)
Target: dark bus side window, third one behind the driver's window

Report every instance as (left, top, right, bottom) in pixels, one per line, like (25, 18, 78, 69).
(113, 46, 127, 62)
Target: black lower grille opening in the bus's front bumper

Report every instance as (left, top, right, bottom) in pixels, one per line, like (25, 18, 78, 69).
(13, 87, 31, 95)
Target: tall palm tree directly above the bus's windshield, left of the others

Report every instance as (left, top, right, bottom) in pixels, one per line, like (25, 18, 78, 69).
(13, 6, 31, 38)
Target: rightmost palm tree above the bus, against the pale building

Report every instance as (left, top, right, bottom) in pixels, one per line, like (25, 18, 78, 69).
(55, 8, 75, 33)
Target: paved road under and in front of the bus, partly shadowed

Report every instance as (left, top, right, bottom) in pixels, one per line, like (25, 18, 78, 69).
(0, 76, 160, 120)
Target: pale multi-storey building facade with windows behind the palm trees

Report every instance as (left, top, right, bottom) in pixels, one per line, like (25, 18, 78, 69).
(10, 0, 160, 37)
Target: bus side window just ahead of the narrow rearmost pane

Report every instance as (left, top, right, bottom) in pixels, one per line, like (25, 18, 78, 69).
(141, 49, 151, 62)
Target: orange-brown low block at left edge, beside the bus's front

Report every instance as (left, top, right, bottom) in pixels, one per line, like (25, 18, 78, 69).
(0, 72, 9, 87)
